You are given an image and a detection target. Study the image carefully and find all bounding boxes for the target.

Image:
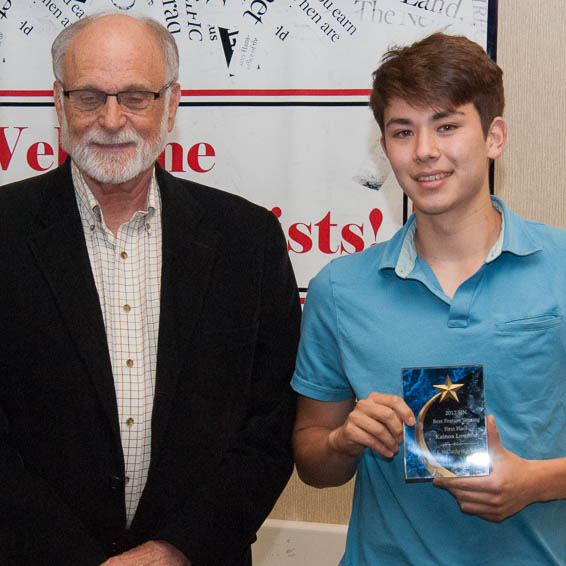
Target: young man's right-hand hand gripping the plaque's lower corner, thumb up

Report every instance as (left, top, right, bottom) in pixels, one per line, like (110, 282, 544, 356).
(434, 415, 536, 523)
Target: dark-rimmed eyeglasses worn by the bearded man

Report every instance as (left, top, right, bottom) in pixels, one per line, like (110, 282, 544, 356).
(63, 82, 173, 112)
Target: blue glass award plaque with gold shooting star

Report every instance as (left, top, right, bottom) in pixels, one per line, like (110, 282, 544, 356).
(401, 365, 490, 481)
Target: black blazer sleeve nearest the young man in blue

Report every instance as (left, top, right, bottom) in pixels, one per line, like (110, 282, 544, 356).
(153, 213, 301, 566)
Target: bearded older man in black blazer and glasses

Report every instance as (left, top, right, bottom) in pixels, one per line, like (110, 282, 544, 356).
(0, 14, 300, 566)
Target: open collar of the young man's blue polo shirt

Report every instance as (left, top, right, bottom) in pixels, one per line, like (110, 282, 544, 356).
(379, 196, 542, 279)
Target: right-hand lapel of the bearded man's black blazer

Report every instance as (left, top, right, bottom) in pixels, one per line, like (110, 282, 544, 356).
(151, 167, 219, 460)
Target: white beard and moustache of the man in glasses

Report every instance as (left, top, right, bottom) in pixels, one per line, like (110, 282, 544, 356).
(61, 93, 169, 185)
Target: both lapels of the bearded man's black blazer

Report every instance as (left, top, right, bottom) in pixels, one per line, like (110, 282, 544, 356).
(28, 163, 219, 459)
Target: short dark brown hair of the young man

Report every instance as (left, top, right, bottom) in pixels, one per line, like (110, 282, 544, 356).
(369, 33, 505, 136)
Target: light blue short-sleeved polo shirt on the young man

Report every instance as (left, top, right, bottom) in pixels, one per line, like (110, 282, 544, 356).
(292, 198, 566, 566)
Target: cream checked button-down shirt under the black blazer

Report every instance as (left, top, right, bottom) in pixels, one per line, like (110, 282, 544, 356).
(72, 163, 162, 526)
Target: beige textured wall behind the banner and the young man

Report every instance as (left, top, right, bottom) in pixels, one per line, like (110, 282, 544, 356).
(271, 0, 566, 523)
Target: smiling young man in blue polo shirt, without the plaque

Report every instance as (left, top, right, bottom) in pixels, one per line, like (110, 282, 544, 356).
(292, 34, 566, 566)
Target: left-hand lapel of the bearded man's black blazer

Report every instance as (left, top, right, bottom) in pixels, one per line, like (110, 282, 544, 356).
(28, 163, 121, 446)
